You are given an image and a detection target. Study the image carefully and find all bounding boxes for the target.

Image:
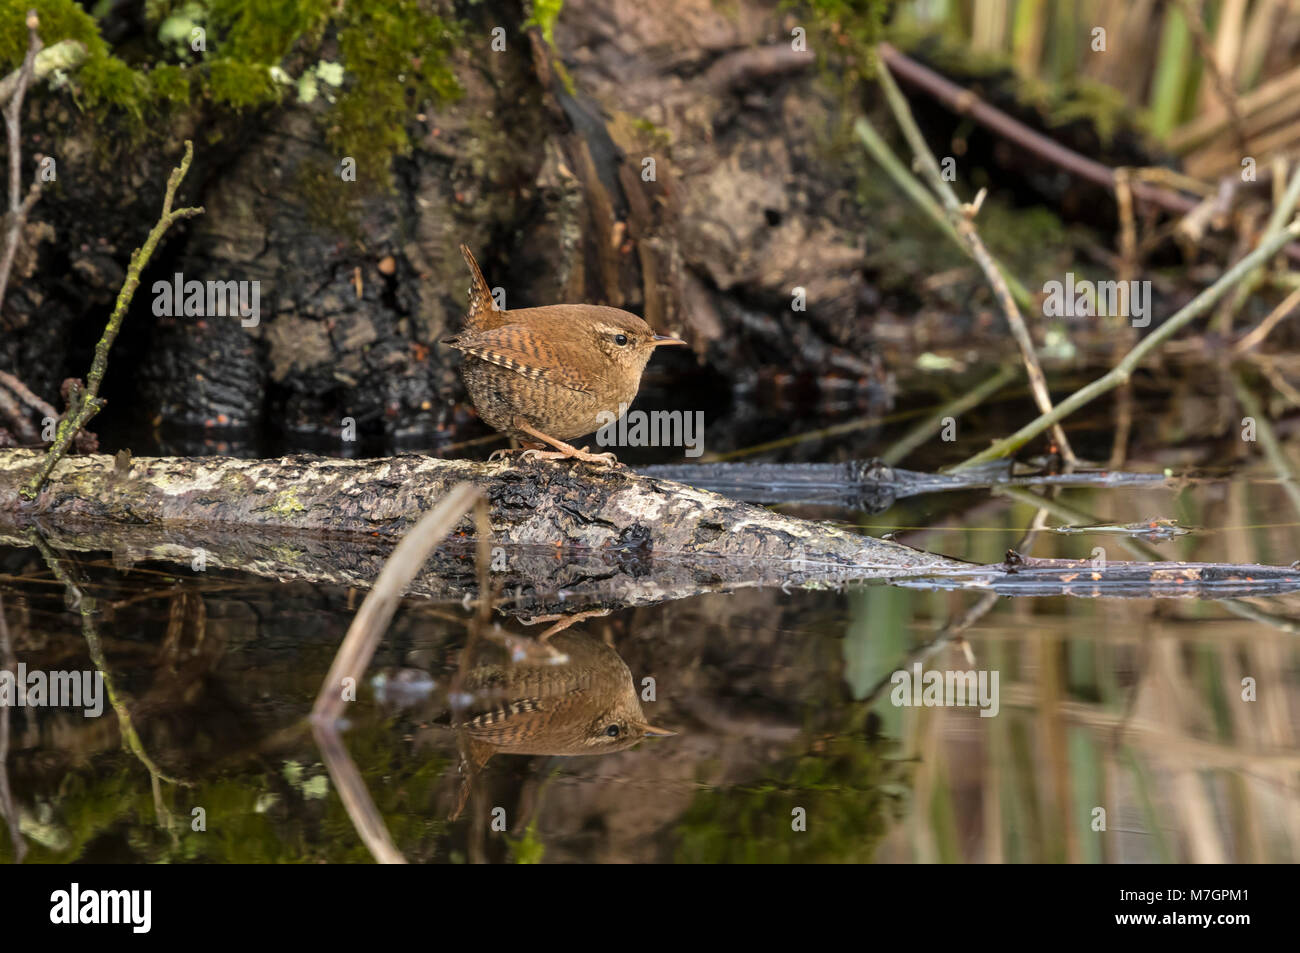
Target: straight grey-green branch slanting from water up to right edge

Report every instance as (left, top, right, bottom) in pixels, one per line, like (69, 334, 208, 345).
(952, 213, 1300, 471)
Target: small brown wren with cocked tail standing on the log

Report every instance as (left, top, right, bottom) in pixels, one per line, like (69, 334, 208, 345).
(443, 246, 686, 463)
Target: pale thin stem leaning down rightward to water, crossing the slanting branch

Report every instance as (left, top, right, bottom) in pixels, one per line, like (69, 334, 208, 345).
(879, 55, 1078, 467)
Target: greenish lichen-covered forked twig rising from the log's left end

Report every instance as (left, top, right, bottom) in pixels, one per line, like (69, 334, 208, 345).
(22, 139, 203, 499)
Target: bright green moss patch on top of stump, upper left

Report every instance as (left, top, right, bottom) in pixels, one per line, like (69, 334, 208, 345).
(0, 0, 465, 183)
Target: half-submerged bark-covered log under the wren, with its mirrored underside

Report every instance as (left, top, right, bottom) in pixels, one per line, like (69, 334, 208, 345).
(0, 450, 1300, 616)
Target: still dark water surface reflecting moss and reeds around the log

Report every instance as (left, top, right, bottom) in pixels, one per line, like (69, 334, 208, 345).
(0, 379, 1300, 863)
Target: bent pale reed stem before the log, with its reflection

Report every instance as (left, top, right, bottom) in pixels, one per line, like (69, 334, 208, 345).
(311, 484, 491, 863)
